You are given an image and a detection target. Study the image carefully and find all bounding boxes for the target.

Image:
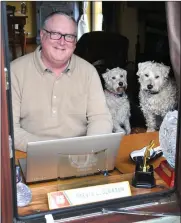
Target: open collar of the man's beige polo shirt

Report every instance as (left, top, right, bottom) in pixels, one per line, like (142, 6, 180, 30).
(33, 46, 76, 76)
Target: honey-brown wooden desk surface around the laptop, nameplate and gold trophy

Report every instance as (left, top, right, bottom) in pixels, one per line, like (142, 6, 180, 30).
(16, 132, 168, 216)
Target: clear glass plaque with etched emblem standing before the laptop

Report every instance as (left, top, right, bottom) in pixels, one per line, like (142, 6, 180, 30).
(57, 150, 108, 190)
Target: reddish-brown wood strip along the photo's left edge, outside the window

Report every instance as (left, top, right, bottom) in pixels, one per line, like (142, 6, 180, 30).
(1, 43, 13, 223)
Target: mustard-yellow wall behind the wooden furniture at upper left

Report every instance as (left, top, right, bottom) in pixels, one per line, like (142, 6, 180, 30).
(6, 1, 36, 38)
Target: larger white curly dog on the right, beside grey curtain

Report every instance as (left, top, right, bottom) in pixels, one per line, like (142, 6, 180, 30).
(137, 61, 177, 132)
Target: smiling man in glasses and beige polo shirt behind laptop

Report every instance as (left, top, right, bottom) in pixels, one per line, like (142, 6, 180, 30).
(11, 12, 112, 151)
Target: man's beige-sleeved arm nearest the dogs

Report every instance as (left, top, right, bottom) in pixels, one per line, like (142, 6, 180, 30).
(87, 69, 113, 135)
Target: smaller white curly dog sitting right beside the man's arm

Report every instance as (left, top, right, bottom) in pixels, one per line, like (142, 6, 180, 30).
(102, 67, 131, 134)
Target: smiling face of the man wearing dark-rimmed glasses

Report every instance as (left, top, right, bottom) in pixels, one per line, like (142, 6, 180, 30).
(40, 15, 76, 65)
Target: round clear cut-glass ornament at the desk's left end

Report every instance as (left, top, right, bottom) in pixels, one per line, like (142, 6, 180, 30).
(16, 166, 32, 207)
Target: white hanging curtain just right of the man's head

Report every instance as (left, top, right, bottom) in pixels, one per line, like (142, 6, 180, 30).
(77, 2, 89, 40)
